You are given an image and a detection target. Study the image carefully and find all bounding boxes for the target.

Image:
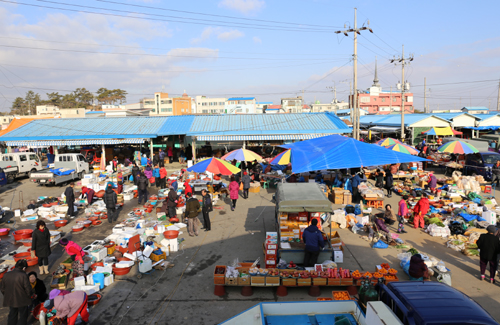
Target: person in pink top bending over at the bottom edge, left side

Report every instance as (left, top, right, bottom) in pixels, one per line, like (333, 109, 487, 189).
(43, 291, 90, 325)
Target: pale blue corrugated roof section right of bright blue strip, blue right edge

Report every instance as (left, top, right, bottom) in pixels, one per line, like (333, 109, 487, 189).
(188, 113, 351, 136)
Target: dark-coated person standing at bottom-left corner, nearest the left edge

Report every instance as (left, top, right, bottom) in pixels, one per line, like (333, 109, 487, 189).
(0, 259, 34, 325)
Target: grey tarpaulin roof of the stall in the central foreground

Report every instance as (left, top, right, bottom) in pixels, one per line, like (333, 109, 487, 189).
(277, 183, 333, 212)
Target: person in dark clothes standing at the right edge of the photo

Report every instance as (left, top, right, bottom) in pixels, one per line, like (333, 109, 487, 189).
(476, 225, 500, 284)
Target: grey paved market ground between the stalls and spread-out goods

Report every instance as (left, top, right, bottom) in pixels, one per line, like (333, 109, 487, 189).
(0, 170, 500, 325)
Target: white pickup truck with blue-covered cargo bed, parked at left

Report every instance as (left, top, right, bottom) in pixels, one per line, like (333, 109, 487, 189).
(30, 153, 89, 185)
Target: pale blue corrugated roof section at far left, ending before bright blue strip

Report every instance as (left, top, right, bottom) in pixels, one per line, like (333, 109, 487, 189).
(0, 117, 167, 141)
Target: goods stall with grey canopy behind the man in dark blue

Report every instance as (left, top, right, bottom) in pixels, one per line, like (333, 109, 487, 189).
(276, 183, 333, 264)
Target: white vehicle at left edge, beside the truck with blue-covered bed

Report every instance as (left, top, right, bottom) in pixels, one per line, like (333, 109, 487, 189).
(0, 152, 43, 182)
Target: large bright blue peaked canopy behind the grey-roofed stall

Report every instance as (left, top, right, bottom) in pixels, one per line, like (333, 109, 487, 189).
(280, 134, 429, 173)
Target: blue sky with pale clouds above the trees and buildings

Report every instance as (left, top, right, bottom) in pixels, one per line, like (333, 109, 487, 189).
(0, 0, 500, 111)
